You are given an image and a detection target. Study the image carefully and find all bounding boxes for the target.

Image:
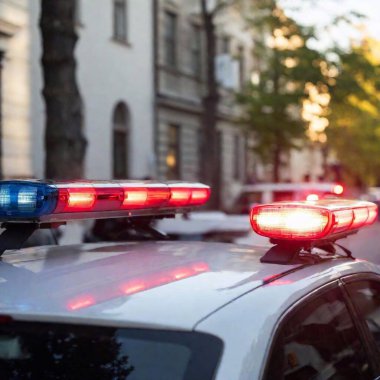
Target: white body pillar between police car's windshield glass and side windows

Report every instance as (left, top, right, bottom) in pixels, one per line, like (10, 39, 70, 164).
(195, 259, 380, 380)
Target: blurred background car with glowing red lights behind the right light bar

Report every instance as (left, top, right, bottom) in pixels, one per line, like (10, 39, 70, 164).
(228, 182, 345, 214)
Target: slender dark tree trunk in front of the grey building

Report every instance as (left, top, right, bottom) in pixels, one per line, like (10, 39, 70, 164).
(201, 0, 221, 209)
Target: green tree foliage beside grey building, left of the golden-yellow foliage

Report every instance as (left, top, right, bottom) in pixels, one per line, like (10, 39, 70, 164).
(238, 0, 326, 181)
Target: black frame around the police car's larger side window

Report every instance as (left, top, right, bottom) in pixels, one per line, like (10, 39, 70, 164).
(259, 277, 377, 380)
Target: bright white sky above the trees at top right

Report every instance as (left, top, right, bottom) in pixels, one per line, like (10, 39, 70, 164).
(280, 0, 380, 48)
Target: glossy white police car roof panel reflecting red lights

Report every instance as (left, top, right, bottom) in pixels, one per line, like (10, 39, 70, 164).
(0, 242, 374, 329)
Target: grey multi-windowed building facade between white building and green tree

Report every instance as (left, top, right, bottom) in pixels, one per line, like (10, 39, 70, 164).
(155, 0, 253, 206)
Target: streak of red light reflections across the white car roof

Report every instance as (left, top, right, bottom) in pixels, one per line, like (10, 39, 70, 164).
(66, 262, 210, 311)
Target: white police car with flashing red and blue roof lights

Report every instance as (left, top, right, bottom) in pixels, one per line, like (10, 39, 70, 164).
(0, 181, 380, 380)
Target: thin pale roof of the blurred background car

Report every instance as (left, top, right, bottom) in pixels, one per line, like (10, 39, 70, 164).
(241, 182, 336, 192)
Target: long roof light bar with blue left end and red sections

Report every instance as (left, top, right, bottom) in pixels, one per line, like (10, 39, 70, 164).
(0, 181, 211, 222)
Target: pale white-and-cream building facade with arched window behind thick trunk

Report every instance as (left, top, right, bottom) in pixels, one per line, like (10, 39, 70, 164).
(0, 0, 155, 179)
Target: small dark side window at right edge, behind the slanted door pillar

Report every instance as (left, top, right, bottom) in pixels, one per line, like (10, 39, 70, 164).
(347, 281, 380, 349)
